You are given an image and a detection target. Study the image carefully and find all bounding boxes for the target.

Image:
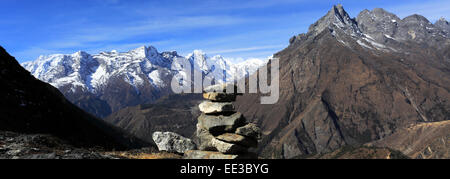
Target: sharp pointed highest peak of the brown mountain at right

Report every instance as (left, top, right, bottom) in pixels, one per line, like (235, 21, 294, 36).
(308, 4, 360, 35)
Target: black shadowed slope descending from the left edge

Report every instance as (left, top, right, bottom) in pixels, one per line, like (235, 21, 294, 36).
(0, 47, 147, 149)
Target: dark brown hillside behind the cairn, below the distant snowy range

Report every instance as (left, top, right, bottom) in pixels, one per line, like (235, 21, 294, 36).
(104, 94, 202, 143)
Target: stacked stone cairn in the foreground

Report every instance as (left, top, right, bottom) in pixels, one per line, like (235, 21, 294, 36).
(185, 84, 261, 159)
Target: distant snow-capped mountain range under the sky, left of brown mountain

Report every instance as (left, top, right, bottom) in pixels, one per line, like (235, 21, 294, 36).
(22, 46, 265, 117)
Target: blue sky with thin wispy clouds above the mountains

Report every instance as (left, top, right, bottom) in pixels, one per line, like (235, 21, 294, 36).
(0, 0, 450, 62)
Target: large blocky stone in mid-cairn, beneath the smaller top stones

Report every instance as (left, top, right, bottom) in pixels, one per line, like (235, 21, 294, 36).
(198, 112, 245, 136)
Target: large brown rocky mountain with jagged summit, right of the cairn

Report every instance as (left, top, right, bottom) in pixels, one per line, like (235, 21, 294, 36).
(237, 5, 450, 158)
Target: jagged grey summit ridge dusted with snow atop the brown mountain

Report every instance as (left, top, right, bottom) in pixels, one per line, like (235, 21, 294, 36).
(296, 4, 450, 52)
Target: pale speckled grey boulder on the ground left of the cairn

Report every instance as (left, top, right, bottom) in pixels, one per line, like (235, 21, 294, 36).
(152, 132, 196, 153)
